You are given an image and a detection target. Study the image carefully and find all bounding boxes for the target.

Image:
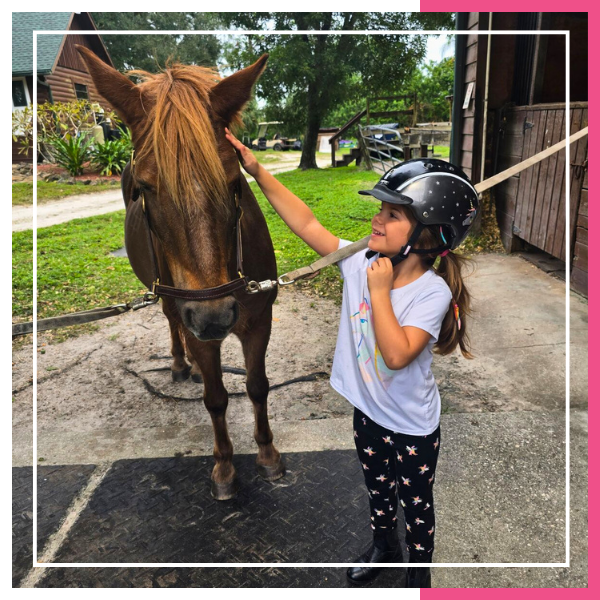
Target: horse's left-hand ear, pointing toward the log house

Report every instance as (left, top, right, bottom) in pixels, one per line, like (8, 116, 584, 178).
(75, 44, 143, 128)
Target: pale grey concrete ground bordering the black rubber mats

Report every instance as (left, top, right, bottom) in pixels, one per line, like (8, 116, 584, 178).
(13, 255, 587, 587)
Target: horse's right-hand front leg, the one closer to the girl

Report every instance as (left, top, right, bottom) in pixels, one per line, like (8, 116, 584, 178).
(239, 310, 285, 481)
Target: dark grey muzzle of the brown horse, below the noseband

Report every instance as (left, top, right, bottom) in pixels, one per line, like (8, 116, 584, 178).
(177, 296, 240, 342)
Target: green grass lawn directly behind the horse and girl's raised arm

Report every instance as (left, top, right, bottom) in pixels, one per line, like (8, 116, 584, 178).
(12, 166, 502, 335)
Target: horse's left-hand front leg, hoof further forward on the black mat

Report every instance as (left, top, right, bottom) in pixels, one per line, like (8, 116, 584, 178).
(186, 334, 238, 500)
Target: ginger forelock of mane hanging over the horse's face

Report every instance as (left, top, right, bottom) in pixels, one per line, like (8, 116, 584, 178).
(130, 63, 237, 213)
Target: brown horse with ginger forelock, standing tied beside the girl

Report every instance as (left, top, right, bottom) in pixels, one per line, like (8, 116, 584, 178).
(77, 46, 285, 500)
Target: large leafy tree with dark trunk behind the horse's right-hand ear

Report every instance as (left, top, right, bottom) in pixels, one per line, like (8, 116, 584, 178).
(220, 12, 454, 169)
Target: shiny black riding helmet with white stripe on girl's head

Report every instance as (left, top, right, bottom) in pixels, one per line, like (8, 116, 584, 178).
(358, 158, 479, 265)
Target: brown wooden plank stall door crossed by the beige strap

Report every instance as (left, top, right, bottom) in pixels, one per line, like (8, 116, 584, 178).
(496, 102, 588, 293)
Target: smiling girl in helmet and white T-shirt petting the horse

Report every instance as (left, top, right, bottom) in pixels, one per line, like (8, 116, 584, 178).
(225, 129, 479, 587)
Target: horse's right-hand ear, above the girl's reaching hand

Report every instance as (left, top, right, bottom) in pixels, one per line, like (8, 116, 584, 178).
(210, 54, 269, 123)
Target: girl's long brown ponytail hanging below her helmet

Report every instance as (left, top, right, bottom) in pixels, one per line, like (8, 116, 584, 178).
(398, 207, 475, 358)
